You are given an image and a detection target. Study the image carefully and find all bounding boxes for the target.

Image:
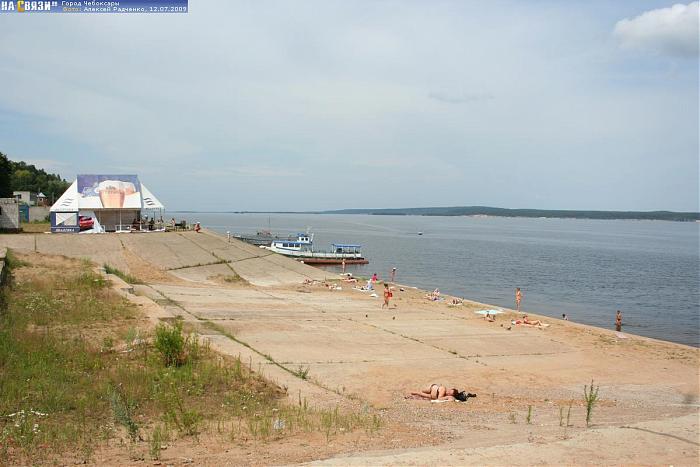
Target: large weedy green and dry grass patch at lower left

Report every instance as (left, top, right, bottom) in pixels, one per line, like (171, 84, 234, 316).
(0, 252, 382, 465)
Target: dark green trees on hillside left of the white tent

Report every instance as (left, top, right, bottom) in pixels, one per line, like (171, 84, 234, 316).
(0, 152, 70, 202)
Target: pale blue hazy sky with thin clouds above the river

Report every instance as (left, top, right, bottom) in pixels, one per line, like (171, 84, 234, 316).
(0, 0, 700, 211)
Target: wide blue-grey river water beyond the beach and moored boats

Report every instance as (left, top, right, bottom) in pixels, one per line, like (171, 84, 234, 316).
(168, 213, 700, 347)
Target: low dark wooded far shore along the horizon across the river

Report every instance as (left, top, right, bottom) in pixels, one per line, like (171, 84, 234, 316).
(171, 206, 700, 222)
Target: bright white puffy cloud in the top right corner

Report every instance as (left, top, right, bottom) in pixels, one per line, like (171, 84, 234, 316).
(614, 2, 699, 57)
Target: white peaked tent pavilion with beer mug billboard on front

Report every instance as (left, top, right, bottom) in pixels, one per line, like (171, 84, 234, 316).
(49, 175, 165, 233)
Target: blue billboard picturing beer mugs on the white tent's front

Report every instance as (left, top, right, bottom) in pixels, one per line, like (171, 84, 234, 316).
(78, 175, 141, 209)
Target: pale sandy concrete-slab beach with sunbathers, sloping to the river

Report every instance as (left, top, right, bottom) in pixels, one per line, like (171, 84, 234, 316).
(0, 231, 700, 465)
